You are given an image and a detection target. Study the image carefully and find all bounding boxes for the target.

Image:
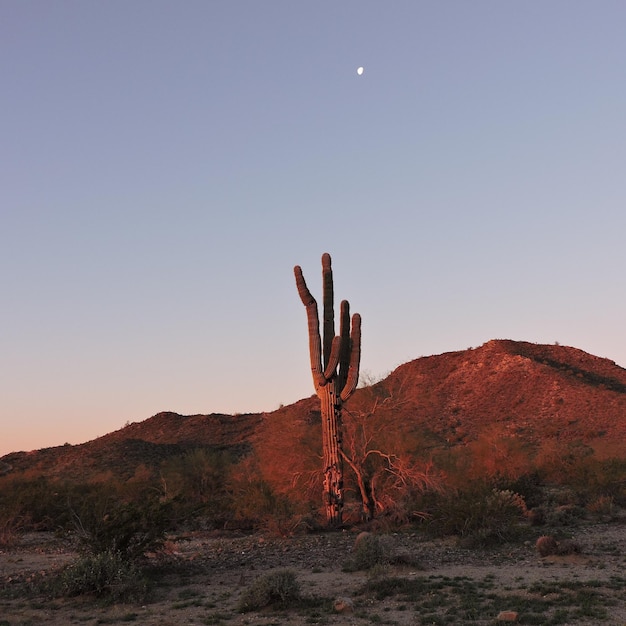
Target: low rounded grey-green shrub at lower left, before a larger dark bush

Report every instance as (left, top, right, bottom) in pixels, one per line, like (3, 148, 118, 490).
(50, 551, 147, 601)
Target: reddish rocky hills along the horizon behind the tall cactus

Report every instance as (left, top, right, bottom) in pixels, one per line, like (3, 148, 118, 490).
(0, 340, 626, 479)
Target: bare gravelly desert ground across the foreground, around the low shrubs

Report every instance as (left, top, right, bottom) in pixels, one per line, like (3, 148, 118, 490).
(0, 521, 626, 626)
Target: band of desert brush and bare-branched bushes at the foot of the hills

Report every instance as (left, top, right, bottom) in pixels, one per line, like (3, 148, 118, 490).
(0, 381, 626, 540)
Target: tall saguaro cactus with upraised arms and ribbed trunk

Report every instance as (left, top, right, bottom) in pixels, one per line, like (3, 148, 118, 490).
(294, 253, 361, 527)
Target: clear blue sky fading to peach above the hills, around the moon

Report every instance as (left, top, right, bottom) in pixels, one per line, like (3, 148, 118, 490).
(0, 0, 626, 454)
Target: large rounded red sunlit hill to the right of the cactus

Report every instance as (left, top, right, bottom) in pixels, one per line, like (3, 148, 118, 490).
(366, 340, 626, 448)
